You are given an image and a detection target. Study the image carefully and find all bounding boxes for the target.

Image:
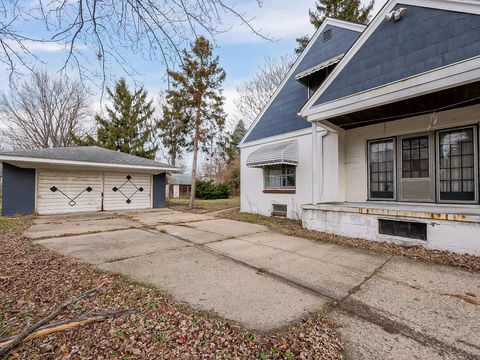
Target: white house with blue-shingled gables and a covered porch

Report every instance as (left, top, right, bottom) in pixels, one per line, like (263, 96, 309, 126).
(241, 0, 480, 255)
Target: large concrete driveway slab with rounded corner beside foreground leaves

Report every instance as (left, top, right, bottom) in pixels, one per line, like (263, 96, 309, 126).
(99, 247, 328, 331)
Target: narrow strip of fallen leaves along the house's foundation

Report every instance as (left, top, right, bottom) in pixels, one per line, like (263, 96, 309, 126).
(217, 210, 480, 271)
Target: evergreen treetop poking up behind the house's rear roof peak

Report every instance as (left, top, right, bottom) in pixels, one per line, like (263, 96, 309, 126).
(295, 0, 374, 54)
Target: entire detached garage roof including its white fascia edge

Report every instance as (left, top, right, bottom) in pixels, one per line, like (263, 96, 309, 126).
(0, 146, 178, 171)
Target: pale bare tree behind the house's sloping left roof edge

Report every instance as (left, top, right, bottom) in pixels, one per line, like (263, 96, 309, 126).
(235, 54, 295, 127)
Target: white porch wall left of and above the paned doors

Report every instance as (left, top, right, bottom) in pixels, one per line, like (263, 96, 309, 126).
(344, 105, 480, 202)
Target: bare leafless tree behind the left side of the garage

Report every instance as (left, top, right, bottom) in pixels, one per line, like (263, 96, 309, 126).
(0, 72, 90, 149)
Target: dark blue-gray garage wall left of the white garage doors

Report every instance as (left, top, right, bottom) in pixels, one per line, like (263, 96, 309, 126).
(2, 163, 35, 216)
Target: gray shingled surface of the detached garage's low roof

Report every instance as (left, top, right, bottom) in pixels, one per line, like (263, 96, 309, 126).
(0, 146, 176, 170)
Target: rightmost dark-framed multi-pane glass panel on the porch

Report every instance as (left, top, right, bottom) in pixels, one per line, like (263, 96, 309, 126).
(438, 128, 475, 201)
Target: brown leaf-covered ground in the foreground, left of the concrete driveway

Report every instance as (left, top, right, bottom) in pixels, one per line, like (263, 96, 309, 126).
(0, 218, 342, 359)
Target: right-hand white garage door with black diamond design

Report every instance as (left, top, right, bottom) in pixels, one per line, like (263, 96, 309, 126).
(103, 173, 152, 210)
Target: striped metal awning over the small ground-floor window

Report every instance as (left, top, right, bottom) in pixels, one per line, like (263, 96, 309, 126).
(247, 140, 298, 168)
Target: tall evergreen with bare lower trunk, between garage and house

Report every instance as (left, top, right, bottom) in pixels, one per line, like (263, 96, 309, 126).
(168, 36, 226, 208)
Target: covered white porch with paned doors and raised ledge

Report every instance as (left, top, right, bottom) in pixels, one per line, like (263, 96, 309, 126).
(302, 83, 480, 255)
